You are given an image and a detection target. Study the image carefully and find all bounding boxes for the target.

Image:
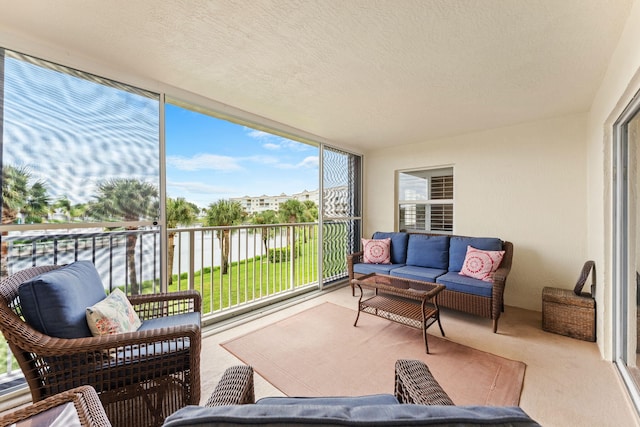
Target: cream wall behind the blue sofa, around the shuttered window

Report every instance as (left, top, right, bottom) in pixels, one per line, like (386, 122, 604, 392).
(364, 114, 587, 311)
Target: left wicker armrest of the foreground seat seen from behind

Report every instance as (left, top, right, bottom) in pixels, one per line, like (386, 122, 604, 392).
(205, 365, 256, 406)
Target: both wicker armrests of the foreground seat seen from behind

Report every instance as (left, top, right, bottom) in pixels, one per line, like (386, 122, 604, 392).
(205, 359, 453, 406)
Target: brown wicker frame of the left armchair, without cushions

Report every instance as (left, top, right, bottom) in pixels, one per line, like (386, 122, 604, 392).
(0, 265, 201, 426)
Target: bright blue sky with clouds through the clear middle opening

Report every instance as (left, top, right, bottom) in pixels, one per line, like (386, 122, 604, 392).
(165, 105, 318, 207)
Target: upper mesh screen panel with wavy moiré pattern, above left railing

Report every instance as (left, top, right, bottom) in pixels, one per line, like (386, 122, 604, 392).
(0, 50, 160, 224)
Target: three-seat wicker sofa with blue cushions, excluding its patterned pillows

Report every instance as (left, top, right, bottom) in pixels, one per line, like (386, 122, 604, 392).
(347, 231, 513, 332)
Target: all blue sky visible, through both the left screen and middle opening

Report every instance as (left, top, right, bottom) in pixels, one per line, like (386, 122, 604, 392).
(3, 52, 318, 208)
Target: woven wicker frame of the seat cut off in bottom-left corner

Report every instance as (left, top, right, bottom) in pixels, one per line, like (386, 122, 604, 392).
(0, 385, 111, 427)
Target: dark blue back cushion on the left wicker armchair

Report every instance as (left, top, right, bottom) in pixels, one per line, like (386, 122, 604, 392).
(18, 261, 106, 338)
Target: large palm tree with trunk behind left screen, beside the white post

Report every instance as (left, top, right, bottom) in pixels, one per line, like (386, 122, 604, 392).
(87, 178, 159, 295)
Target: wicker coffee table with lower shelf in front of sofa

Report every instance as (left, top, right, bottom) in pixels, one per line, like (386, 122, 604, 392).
(351, 273, 445, 353)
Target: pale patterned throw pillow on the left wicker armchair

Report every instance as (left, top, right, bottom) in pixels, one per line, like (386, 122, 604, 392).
(87, 288, 142, 337)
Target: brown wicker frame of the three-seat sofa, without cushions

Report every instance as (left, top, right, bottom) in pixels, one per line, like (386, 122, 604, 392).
(347, 233, 513, 333)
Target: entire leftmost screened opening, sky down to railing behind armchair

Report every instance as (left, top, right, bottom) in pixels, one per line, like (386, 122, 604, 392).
(0, 49, 160, 293)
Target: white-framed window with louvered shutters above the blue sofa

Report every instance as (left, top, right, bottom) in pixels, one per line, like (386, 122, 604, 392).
(397, 168, 453, 234)
